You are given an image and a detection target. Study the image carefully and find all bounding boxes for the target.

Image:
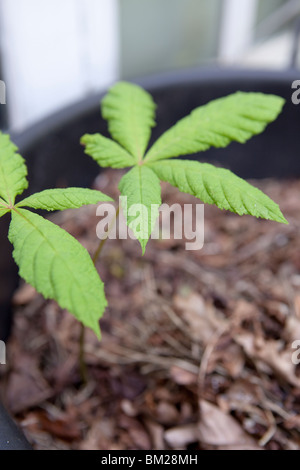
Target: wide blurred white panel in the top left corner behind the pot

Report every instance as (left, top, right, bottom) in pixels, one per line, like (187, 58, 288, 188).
(0, 0, 118, 129)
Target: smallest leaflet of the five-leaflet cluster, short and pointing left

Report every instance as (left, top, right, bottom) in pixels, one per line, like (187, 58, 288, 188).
(80, 134, 136, 168)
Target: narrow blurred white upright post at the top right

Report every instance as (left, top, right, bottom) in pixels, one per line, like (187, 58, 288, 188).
(219, 0, 258, 62)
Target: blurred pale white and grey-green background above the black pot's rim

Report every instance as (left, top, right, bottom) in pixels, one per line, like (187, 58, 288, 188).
(0, 0, 300, 131)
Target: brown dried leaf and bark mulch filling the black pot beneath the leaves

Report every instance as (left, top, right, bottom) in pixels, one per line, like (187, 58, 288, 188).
(0, 171, 300, 450)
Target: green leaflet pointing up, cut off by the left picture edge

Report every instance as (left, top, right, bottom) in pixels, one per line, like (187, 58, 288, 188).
(0, 132, 28, 205)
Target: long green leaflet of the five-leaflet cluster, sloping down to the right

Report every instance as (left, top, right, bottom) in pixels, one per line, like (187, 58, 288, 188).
(149, 160, 288, 224)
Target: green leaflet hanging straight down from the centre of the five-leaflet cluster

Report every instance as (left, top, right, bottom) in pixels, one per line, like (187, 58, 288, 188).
(119, 166, 161, 254)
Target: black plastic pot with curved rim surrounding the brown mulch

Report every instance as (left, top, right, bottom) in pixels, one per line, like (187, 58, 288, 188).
(0, 68, 300, 449)
